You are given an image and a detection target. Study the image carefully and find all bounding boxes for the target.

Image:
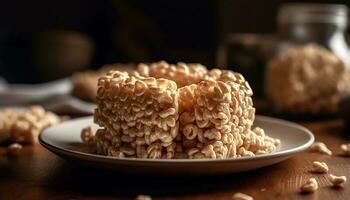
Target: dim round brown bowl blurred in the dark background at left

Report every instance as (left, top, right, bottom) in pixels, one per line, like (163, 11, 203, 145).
(33, 30, 94, 80)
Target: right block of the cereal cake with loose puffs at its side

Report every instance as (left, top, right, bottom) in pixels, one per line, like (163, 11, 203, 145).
(179, 71, 278, 158)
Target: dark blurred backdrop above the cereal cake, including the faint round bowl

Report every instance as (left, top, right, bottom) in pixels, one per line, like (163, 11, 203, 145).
(0, 0, 350, 83)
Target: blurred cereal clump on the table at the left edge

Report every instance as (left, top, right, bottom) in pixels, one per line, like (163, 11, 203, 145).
(0, 106, 62, 144)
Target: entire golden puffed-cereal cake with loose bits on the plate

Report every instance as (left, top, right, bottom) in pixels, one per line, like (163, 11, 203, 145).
(86, 61, 280, 159)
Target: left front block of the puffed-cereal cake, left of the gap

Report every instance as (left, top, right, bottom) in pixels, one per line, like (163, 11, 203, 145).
(95, 71, 178, 158)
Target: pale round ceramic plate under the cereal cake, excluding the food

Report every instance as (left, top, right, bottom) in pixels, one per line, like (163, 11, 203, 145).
(39, 116, 314, 175)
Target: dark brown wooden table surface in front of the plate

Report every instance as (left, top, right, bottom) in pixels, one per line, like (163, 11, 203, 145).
(0, 120, 350, 200)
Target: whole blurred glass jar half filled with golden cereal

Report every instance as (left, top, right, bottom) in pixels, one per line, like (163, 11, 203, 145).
(264, 4, 350, 115)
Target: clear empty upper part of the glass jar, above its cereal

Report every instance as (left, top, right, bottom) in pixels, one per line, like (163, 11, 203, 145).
(274, 3, 350, 69)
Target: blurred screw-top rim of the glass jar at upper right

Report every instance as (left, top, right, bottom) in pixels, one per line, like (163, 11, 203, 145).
(277, 3, 348, 27)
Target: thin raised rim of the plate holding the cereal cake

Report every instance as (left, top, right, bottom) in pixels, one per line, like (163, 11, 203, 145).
(39, 115, 315, 164)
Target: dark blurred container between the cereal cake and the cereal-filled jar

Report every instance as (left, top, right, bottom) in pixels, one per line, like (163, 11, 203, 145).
(217, 33, 276, 97)
